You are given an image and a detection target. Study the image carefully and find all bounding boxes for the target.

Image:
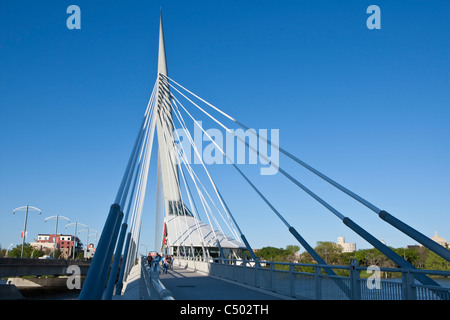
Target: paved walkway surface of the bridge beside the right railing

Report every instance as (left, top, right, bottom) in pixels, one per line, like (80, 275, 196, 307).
(159, 266, 288, 300)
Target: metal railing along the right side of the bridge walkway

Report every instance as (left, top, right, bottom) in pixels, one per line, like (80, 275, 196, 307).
(175, 257, 450, 300)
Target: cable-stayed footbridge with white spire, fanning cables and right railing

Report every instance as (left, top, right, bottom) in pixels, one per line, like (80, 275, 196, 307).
(79, 14, 450, 300)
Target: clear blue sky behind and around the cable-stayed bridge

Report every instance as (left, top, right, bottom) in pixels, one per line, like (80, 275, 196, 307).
(0, 0, 450, 255)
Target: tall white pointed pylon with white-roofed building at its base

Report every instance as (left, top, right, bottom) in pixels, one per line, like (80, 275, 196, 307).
(154, 17, 250, 258)
